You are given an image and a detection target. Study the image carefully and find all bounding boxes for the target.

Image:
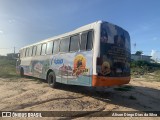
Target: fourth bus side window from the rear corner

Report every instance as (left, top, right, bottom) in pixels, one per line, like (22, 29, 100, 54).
(60, 37, 70, 52)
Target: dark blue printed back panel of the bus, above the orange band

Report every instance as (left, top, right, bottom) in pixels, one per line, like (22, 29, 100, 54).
(97, 22, 131, 77)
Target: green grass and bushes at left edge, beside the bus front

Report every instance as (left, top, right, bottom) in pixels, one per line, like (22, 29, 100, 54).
(0, 58, 19, 78)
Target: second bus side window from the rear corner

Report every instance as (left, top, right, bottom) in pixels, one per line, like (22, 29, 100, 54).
(80, 32, 87, 50)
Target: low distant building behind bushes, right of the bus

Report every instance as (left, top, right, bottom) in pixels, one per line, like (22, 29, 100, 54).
(131, 54, 152, 62)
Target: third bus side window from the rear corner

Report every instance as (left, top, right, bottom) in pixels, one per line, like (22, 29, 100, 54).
(70, 35, 80, 51)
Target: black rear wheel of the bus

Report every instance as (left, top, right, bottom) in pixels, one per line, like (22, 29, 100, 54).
(47, 72, 57, 88)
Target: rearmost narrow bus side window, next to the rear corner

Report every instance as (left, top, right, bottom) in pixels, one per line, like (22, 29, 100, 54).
(87, 31, 93, 50)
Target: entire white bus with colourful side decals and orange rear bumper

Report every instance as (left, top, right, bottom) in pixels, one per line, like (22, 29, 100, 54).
(17, 21, 131, 87)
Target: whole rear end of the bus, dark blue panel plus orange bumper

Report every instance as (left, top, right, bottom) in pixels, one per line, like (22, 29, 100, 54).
(92, 22, 131, 86)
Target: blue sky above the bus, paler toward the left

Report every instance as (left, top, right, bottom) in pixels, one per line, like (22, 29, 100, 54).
(0, 0, 160, 58)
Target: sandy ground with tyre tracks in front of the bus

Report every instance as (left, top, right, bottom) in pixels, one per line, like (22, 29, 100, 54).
(0, 78, 160, 120)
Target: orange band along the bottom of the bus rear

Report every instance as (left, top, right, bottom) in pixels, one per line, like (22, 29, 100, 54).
(92, 75, 130, 86)
